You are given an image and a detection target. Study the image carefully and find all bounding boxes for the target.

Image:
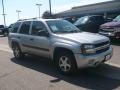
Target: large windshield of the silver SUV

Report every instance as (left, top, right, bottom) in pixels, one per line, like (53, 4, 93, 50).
(46, 20, 80, 33)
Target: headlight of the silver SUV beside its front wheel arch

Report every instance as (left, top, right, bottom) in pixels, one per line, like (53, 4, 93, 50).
(82, 44, 96, 54)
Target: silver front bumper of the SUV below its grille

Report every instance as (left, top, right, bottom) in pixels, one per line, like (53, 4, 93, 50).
(75, 47, 113, 68)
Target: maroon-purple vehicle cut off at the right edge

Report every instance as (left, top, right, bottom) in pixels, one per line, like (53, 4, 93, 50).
(99, 15, 120, 39)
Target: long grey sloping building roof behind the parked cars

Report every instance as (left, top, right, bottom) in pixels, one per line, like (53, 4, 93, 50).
(54, 0, 120, 18)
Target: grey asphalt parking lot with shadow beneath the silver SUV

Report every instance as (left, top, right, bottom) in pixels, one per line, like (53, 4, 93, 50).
(0, 36, 120, 90)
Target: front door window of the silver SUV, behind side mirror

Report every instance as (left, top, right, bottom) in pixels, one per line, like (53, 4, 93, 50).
(31, 21, 46, 35)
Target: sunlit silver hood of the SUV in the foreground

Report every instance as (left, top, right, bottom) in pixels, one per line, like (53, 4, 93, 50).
(57, 32, 109, 44)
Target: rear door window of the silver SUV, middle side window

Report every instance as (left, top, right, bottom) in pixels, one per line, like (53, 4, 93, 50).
(19, 21, 31, 34)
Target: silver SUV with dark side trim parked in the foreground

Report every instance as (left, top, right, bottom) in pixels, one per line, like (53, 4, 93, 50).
(8, 19, 112, 74)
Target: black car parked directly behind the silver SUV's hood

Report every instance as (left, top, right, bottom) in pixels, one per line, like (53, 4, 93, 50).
(74, 15, 105, 33)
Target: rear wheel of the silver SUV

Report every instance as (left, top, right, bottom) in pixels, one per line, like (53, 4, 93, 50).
(13, 44, 24, 59)
